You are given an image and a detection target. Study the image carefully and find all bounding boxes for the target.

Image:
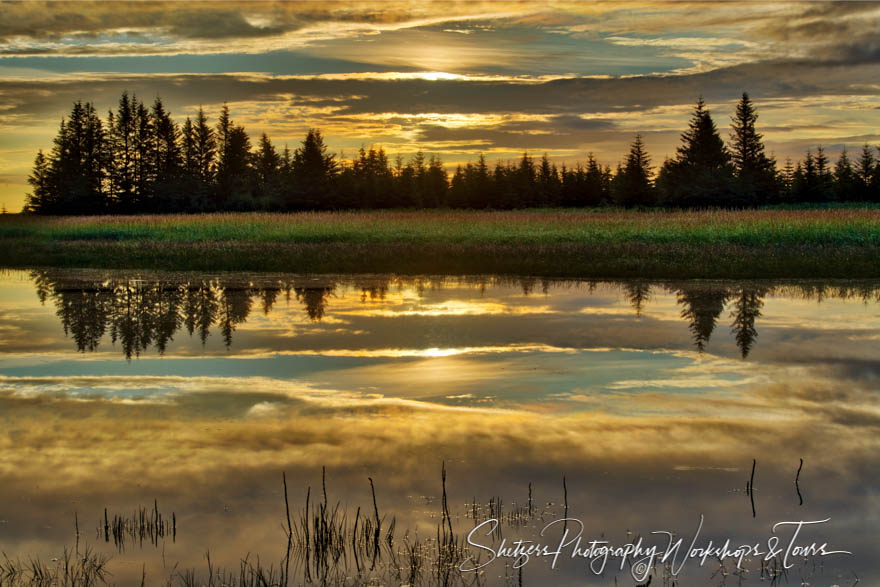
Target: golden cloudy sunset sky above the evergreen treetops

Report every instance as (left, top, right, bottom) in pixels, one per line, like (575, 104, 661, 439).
(0, 2, 880, 211)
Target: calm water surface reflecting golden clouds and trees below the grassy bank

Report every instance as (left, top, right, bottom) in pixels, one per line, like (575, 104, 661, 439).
(0, 270, 880, 585)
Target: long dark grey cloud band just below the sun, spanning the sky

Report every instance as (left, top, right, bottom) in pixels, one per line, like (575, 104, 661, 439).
(0, 54, 880, 124)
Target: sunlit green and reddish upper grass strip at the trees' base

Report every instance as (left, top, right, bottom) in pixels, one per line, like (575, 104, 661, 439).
(0, 208, 880, 246)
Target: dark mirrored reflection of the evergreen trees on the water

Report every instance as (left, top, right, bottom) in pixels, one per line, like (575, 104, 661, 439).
(20, 271, 880, 359)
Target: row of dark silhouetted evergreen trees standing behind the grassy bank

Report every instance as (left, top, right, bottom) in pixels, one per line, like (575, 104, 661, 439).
(25, 92, 880, 214)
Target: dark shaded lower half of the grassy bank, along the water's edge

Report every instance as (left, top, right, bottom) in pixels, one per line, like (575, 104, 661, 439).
(2, 239, 880, 279)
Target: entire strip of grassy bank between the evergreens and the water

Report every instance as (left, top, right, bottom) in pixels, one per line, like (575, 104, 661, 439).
(0, 208, 880, 278)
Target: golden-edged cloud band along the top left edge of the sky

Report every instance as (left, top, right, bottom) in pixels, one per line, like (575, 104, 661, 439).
(0, 2, 531, 55)
